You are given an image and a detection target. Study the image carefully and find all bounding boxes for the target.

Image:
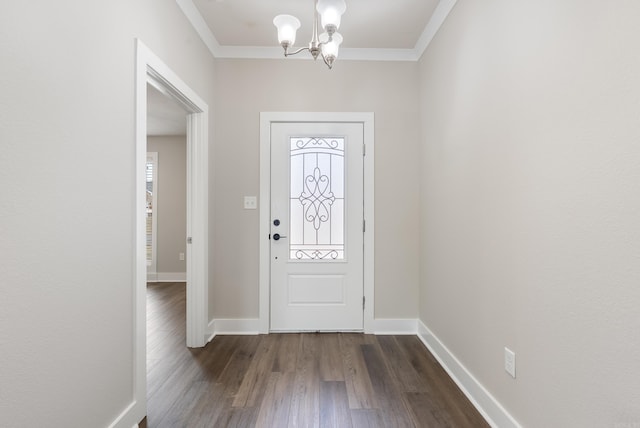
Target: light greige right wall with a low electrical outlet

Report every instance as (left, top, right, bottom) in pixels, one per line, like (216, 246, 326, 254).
(420, 0, 640, 427)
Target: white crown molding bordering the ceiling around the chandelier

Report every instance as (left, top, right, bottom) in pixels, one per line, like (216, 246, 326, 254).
(176, 0, 457, 61)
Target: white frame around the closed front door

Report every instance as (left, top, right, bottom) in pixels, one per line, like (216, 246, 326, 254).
(258, 112, 375, 334)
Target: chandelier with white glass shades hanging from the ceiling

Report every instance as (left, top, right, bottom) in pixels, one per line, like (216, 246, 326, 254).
(273, 0, 347, 69)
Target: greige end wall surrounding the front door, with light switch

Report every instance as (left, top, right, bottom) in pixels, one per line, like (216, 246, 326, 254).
(209, 59, 419, 319)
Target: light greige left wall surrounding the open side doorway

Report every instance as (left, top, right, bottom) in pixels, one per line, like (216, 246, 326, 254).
(0, 0, 214, 427)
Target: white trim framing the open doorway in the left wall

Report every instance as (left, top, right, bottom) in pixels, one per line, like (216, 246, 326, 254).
(133, 40, 209, 419)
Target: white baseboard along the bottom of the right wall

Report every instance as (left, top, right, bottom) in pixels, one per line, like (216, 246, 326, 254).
(418, 321, 521, 428)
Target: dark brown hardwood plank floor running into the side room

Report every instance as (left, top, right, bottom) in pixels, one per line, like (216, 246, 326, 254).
(141, 283, 488, 428)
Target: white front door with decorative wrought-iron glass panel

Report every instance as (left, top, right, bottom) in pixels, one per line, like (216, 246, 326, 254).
(270, 122, 364, 331)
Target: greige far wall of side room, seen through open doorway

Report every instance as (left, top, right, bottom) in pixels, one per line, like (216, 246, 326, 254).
(147, 136, 187, 274)
